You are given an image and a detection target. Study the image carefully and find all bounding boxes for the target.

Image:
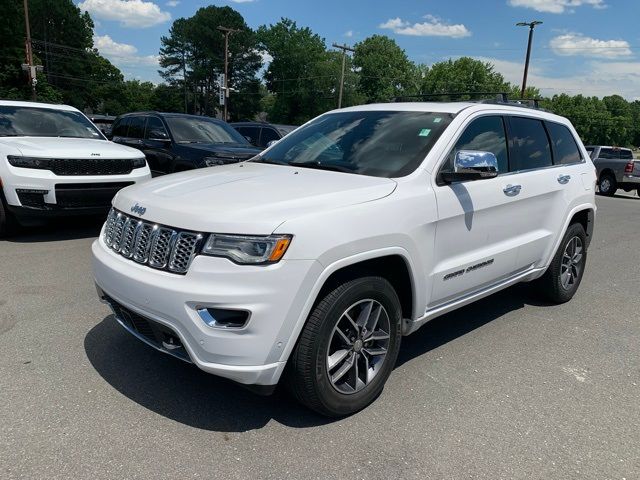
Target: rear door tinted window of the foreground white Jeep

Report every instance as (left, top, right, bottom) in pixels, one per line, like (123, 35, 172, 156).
(510, 117, 552, 172)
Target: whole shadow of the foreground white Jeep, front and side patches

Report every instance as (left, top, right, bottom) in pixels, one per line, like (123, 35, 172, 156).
(84, 285, 545, 432)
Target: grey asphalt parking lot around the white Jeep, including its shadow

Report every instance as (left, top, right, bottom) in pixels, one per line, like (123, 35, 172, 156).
(0, 195, 640, 479)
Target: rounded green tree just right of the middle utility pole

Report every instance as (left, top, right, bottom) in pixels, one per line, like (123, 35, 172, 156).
(353, 35, 418, 102)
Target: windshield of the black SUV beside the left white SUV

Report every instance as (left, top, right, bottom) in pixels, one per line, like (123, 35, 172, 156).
(166, 117, 249, 145)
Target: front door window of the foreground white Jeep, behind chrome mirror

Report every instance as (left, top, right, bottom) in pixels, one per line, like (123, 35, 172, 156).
(442, 117, 509, 173)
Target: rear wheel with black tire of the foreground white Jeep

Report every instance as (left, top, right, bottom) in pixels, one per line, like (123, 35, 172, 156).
(538, 223, 587, 303)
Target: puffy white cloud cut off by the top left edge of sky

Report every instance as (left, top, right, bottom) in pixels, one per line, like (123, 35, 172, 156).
(78, 0, 171, 28)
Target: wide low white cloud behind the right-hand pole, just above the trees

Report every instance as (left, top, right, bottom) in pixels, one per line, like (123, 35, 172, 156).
(475, 57, 640, 100)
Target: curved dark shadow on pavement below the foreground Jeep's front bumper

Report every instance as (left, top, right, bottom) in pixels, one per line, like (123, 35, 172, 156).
(84, 315, 332, 432)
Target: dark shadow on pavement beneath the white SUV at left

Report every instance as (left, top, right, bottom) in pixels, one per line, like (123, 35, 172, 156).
(5, 214, 106, 243)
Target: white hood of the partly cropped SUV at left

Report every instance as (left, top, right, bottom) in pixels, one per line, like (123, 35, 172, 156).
(0, 137, 143, 158)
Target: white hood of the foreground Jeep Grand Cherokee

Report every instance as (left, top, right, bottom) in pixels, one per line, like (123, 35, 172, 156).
(113, 162, 396, 235)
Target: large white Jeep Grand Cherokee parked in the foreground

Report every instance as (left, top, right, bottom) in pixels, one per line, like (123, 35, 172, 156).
(93, 103, 596, 415)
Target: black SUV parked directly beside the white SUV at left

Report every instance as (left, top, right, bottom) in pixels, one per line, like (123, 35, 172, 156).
(112, 112, 260, 176)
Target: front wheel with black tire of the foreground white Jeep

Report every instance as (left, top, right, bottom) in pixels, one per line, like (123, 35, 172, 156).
(286, 276, 402, 417)
